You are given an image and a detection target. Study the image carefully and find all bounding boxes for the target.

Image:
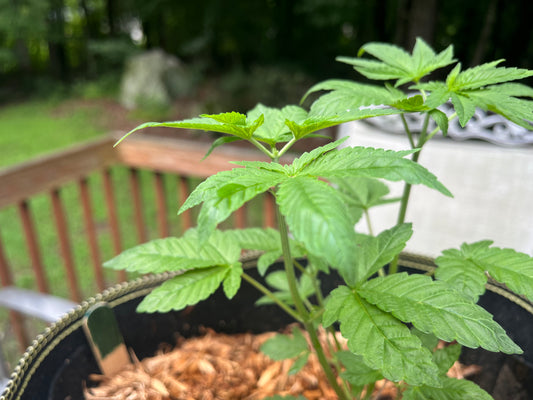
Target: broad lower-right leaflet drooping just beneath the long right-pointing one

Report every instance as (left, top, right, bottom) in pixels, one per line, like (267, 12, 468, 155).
(323, 286, 441, 387)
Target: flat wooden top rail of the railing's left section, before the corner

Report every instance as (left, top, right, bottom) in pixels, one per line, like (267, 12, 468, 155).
(0, 137, 117, 208)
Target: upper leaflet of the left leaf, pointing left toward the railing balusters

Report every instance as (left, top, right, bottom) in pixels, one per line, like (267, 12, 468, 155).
(104, 230, 241, 273)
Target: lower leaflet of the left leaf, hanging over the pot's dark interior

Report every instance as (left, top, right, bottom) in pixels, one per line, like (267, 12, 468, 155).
(137, 265, 230, 312)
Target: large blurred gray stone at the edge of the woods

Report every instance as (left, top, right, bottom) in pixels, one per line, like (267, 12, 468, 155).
(120, 49, 194, 109)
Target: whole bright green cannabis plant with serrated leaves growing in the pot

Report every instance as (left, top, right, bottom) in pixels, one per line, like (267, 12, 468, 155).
(107, 40, 533, 400)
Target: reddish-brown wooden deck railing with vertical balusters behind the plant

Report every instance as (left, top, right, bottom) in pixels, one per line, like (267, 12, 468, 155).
(0, 135, 275, 356)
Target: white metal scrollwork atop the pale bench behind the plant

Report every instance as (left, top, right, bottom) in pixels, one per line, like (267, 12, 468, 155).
(365, 103, 533, 146)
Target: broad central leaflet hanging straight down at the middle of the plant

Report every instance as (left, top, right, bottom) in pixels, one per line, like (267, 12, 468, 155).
(277, 176, 355, 282)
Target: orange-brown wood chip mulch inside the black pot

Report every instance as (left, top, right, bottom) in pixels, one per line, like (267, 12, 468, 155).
(85, 331, 478, 400)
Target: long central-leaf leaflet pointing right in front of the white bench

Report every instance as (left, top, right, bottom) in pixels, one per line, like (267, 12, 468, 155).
(299, 147, 451, 197)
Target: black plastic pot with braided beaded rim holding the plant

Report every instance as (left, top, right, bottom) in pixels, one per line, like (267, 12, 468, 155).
(0, 256, 533, 400)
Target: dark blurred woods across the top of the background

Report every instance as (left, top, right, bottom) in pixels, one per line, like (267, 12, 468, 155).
(0, 0, 533, 98)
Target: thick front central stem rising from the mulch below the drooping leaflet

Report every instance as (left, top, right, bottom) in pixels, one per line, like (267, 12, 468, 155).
(276, 207, 349, 400)
